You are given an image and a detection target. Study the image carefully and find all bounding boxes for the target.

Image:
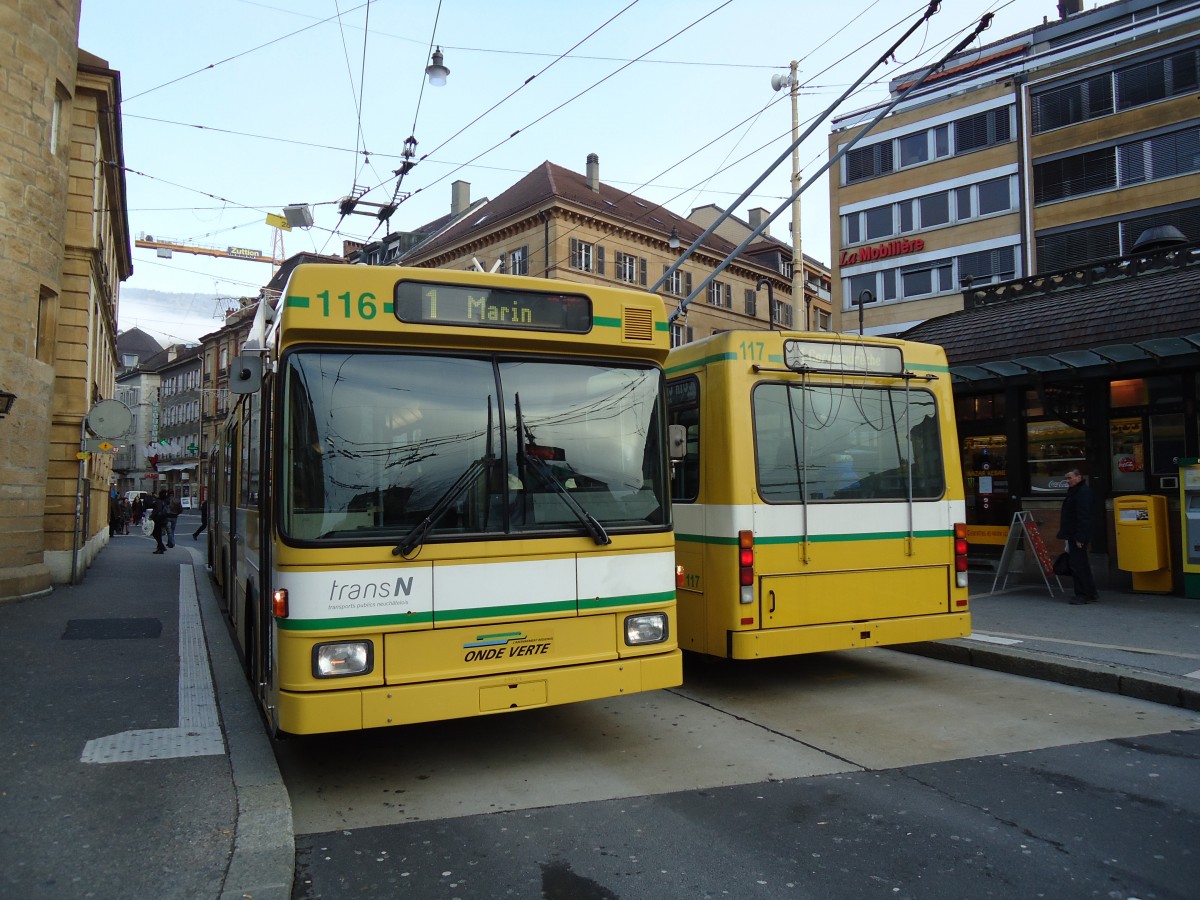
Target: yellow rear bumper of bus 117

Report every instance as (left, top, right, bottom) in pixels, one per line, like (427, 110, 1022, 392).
(728, 612, 971, 659)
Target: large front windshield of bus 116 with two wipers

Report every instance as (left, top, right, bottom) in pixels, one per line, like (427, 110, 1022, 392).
(277, 352, 670, 542)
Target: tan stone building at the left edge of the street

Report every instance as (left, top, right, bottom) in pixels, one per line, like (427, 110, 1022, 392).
(0, 0, 132, 607)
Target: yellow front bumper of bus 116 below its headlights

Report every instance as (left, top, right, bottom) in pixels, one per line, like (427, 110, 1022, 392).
(276, 649, 683, 734)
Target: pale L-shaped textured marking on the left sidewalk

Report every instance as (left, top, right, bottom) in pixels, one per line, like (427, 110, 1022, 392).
(79, 565, 226, 763)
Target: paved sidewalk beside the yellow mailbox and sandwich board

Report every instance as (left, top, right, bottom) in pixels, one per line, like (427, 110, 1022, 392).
(898, 575, 1200, 710)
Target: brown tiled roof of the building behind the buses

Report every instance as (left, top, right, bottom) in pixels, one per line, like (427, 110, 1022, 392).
(415, 161, 736, 258)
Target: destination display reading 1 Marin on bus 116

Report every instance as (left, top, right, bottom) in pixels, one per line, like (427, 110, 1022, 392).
(395, 281, 592, 335)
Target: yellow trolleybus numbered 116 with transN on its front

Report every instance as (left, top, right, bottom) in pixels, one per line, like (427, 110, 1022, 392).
(210, 265, 683, 734)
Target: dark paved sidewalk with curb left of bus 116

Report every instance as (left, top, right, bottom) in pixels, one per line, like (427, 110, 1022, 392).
(0, 526, 294, 900)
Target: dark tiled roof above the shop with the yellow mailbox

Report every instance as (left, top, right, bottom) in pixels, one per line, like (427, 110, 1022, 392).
(904, 253, 1200, 366)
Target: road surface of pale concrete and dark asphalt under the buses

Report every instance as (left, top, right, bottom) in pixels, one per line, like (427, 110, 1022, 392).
(276, 649, 1200, 900)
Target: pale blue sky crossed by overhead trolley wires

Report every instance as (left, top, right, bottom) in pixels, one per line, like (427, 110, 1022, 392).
(79, 0, 1065, 344)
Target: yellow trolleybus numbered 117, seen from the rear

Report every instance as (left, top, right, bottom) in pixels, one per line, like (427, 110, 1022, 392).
(667, 331, 971, 659)
